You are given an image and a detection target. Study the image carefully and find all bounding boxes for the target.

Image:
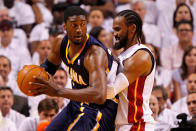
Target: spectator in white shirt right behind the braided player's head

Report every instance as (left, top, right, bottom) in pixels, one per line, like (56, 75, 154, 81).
(131, 0, 161, 48)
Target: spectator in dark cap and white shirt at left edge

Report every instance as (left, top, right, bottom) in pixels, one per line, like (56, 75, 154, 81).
(0, 20, 31, 79)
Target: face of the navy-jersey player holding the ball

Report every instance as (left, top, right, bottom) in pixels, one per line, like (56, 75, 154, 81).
(66, 15, 87, 45)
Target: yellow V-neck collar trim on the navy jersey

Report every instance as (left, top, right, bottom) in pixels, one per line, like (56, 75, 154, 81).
(65, 34, 89, 64)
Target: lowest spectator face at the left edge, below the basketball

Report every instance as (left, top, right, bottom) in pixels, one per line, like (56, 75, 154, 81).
(0, 90, 14, 111)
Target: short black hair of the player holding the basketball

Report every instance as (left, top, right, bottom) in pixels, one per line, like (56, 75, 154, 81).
(64, 6, 87, 23)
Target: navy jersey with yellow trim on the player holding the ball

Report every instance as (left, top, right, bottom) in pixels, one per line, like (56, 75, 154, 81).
(60, 34, 113, 89)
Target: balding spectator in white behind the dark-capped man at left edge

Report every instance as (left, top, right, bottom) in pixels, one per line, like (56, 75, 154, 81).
(0, 7, 27, 48)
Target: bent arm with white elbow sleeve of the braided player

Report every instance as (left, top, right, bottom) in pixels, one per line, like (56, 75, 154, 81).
(107, 50, 152, 99)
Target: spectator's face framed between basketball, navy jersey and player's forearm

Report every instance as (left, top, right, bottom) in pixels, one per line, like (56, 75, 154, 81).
(53, 70, 67, 88)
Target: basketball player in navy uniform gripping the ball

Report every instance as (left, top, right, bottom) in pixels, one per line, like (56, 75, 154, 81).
(30, 6, 117, 131)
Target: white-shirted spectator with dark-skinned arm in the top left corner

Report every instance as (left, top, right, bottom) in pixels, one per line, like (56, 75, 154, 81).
(3, 0, 35, 37)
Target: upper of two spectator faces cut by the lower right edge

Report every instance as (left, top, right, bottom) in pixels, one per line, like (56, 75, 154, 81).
(187, 73, 196, 92)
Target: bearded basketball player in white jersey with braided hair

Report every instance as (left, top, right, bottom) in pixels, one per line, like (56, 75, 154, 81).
(107, 10, 155, 131)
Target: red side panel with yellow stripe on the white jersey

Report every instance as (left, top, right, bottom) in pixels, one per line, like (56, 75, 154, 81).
(127, 76, 147, 123)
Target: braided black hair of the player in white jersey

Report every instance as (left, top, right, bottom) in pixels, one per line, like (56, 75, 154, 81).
(117, 10, 142, 43)
